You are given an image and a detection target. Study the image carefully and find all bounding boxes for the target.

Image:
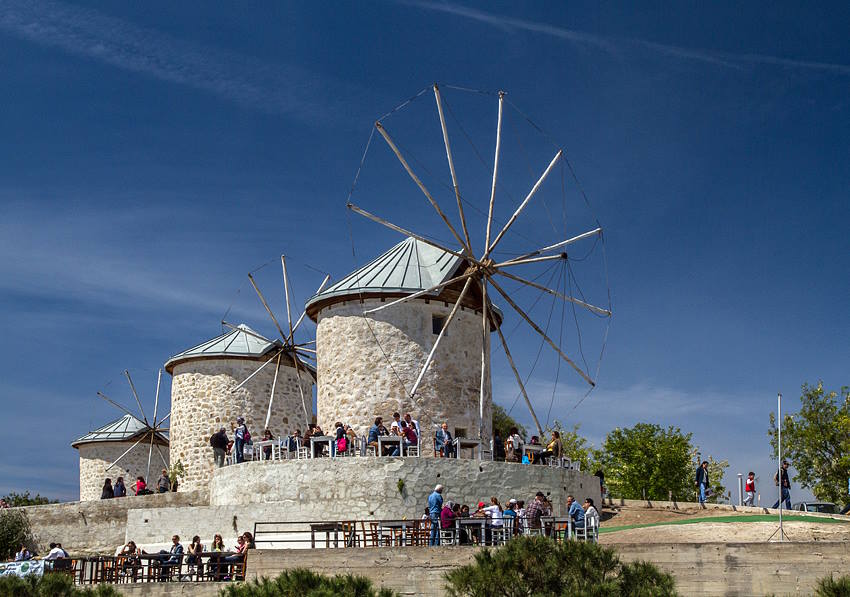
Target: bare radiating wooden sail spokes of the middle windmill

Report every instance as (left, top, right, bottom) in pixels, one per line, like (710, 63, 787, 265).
(221, 255, 330, 428)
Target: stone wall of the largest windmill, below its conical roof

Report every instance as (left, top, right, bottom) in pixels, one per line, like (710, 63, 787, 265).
(316, 299, 492, 448)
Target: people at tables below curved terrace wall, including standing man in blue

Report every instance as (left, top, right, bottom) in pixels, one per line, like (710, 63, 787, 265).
(422, 485, 600, 546)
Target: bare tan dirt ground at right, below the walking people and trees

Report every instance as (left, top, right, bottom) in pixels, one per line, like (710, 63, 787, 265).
(599, 508, 850, 545)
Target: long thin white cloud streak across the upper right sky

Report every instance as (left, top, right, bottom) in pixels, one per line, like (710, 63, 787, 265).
(398, 0, 850, 75)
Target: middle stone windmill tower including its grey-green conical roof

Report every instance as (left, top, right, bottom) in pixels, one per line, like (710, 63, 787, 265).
(165, 324, 315, 490)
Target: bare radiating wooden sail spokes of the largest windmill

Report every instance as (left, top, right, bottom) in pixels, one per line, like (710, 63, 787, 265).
(347, 84, 612, 436)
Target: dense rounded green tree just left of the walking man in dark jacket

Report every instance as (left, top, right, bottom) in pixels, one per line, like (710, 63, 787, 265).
(596, 423, 694, 500)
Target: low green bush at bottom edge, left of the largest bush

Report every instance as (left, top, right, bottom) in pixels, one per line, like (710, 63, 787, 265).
(219, 568, 396, 597)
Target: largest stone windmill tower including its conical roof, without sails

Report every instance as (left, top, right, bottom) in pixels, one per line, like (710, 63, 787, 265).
(307, 238, 501, 448)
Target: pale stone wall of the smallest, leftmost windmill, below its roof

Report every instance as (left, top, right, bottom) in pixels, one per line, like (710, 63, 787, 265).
(79, 441, 168, 501)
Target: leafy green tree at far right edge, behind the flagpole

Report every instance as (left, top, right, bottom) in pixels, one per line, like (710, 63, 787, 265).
(767, 381, 850, 503)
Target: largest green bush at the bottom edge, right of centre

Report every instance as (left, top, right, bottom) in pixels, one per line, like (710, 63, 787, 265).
(446, 537, 676, 597)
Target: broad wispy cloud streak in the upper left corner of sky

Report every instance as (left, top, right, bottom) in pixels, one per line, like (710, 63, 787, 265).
(0, 0, 354, 120)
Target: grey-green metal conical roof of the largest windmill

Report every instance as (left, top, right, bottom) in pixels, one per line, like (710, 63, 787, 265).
(307, 237, 465, 319)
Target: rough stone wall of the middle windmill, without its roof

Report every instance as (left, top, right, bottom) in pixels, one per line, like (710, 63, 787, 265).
(170, 359, 313, 490)
